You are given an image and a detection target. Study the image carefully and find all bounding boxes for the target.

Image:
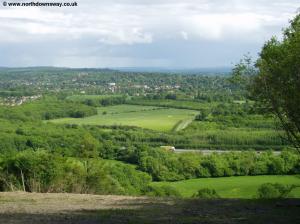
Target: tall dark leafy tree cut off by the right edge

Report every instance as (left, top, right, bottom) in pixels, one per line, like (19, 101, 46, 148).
(252, 14, 300, 150)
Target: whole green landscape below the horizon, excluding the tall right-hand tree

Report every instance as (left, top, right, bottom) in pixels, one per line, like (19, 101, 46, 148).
(0, 65, 300, 223)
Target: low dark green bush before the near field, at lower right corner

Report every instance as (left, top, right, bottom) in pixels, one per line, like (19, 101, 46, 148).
(257, 183, 296, 199)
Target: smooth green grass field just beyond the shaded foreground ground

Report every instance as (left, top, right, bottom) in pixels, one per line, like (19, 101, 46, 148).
(153, 175, 300, 199)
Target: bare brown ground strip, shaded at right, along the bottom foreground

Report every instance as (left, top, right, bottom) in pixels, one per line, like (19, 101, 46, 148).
(0, 192, 300, 224)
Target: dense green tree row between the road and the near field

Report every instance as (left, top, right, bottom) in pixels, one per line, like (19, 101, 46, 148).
(127, 149, 300, 181)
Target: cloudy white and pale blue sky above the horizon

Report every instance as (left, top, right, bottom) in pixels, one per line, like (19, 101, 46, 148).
(0, 0, 300, 68)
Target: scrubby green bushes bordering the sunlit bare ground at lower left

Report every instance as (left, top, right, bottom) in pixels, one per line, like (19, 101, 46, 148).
(0, 150, 151, 195)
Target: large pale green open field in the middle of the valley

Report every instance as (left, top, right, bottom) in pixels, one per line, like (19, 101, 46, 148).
(51, 105, 197, 131)
